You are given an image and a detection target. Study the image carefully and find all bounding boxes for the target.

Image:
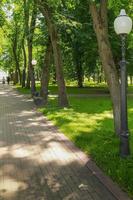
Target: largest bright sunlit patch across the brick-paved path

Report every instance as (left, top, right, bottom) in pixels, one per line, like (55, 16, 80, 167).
(0, 134, 80, 166)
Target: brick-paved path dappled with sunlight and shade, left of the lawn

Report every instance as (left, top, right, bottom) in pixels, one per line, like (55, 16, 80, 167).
(0, 85, 130, 200)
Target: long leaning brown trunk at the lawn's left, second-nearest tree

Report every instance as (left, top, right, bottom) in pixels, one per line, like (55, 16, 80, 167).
(37, 0, 68, 107)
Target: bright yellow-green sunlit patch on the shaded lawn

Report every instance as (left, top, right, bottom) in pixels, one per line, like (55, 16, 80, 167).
(48, 109, 113, 133)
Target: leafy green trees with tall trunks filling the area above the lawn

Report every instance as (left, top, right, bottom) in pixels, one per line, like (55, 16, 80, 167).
(0, 0, 133, 134)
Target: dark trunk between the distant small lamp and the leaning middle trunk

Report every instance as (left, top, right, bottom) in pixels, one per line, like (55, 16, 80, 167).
(40, 41, 52, 104)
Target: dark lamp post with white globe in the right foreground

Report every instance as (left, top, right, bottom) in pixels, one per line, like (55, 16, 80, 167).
(114, 9, 132, 157)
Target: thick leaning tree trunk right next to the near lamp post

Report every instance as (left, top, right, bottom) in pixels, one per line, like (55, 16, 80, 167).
(90, 0, 121, 134)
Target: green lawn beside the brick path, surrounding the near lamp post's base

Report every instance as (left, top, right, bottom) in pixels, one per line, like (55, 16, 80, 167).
(40, 97, 133, 196)
